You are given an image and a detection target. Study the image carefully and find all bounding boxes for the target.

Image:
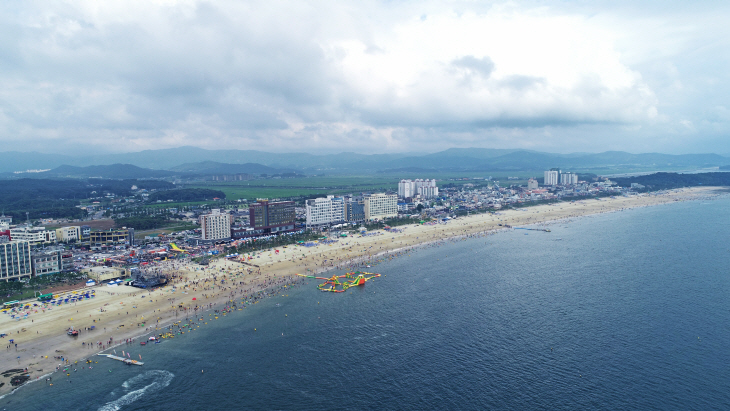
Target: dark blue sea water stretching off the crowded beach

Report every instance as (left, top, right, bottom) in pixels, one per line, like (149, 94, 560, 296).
(0, 197, 730, 410)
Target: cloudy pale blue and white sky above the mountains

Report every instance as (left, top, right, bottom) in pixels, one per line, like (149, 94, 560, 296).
(0, 0, 730, 155)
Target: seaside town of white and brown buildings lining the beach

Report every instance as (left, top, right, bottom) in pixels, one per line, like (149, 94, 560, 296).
(0, 169, 644, 292)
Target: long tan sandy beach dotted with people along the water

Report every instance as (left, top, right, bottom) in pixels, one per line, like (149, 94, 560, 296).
(0, 187, 725, 395)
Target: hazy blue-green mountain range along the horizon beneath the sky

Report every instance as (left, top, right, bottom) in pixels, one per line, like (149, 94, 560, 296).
(0, 147, 730, 178)
